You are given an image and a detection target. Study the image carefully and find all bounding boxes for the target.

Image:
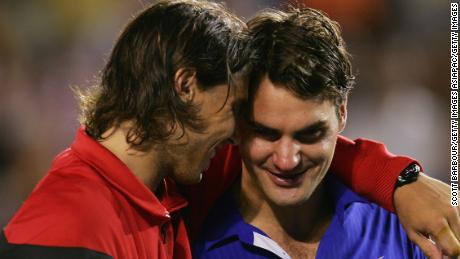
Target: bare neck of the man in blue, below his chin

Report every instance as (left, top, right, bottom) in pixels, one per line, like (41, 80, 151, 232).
(235, 168, 333, 250)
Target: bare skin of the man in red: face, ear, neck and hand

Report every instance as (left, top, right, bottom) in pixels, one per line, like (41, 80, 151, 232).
(97, 70, 460, 258)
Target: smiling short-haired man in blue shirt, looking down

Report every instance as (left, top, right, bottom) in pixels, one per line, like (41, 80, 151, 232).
(193, 9, 424, 258)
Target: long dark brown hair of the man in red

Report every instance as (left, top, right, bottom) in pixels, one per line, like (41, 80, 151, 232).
(79, 0, 245, 146)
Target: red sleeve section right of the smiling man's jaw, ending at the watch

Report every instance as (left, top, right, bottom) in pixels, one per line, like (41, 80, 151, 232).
(330, 136, 418, 212)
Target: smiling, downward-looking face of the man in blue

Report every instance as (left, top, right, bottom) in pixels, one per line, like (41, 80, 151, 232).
(240, 77, 346, 206)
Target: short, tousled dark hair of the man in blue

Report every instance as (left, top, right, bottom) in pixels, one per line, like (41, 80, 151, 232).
(228, 8, 355, 111)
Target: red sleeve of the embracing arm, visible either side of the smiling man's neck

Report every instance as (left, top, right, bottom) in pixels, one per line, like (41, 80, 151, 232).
(187, 136, 417, 240)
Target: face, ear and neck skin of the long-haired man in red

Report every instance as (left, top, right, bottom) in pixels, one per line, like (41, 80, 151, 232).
(100, 69, 244, 190)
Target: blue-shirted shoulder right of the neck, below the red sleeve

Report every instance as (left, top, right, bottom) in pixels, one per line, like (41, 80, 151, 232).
(318, 176, 425, 258)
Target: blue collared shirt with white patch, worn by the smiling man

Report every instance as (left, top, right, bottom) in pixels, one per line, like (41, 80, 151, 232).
(192, 176, 426, 259)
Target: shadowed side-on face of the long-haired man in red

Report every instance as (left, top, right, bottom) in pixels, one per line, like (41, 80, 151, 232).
(164, 84, 245, 184)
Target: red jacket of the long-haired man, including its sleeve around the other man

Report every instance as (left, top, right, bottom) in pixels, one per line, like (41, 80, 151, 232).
(0, 129, 414, 259)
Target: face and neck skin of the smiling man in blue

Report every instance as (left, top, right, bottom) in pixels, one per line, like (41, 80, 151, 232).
(239, 77, 346, 258)
